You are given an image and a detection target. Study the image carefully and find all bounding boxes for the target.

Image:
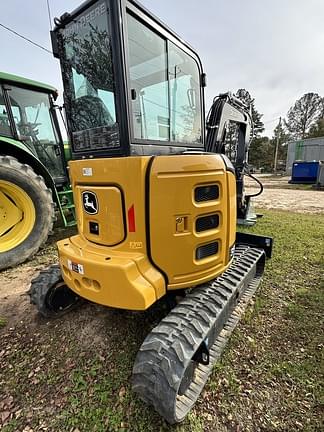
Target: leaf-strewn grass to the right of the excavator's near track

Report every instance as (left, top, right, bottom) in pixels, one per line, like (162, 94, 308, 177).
(202, 211, 324, 431)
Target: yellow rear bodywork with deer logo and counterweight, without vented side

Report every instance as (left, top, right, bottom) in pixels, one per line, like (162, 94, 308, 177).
(58, 157, 166, 310)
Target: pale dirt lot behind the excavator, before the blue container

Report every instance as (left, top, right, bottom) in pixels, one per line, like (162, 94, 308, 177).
(246, 175, 324, 214)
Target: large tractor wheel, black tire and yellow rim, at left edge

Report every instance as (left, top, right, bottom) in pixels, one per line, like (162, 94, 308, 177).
(0, 156, 55, 270)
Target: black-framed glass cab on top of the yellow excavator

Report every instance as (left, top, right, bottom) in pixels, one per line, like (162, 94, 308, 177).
(52, 1, 205, 159)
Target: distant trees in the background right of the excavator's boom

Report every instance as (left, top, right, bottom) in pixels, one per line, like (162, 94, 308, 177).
(236, 89, 324, 171)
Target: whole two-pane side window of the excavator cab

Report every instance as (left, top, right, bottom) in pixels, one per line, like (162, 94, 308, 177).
(127, 14, 202, 146)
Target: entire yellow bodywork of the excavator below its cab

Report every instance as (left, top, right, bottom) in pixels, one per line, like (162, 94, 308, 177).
(58, 154, 236, 310)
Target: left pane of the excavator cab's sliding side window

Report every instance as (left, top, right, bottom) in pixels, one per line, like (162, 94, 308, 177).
(127, 15, 170, 141)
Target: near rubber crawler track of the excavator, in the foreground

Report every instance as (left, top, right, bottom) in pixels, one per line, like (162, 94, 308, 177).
(133, 245, 265, 424)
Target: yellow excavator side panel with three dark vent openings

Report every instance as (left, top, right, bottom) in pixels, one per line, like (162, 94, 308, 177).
(150, 154, 235, 289)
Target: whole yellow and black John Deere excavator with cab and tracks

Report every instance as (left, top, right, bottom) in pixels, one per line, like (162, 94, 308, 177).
(30, 0, 272, 423)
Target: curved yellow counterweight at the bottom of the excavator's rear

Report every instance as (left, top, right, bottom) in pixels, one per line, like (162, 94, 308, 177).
(58, 236, 165, 310)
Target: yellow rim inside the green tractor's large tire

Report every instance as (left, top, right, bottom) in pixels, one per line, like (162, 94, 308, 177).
(0, 180, 36, 252)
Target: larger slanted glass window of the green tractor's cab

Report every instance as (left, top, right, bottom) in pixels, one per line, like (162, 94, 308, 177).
(8, 86, 65, 178)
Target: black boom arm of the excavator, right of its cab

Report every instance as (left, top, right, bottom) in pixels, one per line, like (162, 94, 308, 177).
(206, 92, 262, 219)
